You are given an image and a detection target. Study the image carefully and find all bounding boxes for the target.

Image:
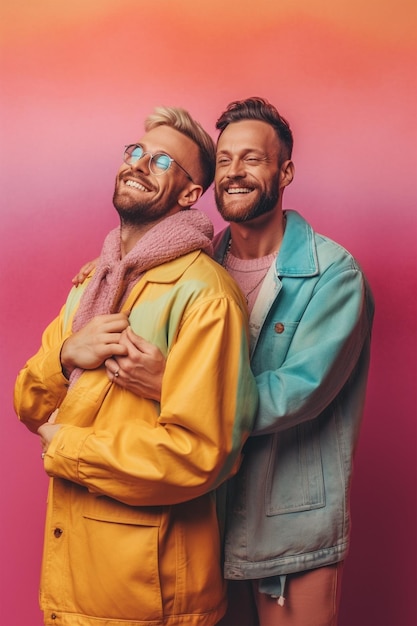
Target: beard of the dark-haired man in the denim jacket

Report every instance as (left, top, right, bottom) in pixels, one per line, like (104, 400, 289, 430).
(214, 174, 280, 224)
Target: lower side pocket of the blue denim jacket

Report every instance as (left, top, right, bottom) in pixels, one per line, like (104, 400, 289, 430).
(265, 420, 326, 515)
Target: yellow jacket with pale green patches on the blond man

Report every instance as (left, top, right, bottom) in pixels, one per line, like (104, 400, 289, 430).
(15, 251, 257, 626)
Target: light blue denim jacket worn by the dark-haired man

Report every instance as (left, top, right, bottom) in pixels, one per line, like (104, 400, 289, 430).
(215, 211, 374, 579)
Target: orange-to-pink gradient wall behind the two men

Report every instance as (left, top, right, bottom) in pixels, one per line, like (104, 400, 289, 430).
(0, 0, 417, 626)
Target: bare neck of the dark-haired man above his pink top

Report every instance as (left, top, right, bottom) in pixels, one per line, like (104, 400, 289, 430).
(230, 211, 285, 260)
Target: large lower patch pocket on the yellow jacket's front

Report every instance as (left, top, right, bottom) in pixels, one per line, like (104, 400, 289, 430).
(75, 496, 163, 623)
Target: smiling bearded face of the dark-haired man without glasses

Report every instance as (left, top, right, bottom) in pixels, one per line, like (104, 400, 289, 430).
(214, 120, 287, 222)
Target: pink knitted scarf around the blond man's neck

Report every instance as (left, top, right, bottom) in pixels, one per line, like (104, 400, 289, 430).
(71, 209, 213, 385)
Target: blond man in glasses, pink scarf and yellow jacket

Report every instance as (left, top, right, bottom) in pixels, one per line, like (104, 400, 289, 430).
(15, 108, 257, 626)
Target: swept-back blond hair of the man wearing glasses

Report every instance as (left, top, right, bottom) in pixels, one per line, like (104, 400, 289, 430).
(145, 107, 216, 191)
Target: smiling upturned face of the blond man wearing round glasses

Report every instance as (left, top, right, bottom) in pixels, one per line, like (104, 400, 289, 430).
(113, 126, 202, 225)
